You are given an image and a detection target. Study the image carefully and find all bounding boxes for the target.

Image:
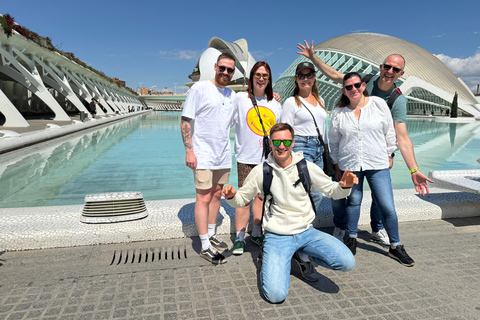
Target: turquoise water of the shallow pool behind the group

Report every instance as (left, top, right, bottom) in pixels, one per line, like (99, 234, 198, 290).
(0, 112, 480, 208)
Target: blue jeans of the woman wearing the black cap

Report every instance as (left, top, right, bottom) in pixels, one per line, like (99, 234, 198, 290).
(293, 135, 324, 211)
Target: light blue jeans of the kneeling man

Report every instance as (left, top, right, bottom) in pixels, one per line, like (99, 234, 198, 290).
(260, 227, 355, 303)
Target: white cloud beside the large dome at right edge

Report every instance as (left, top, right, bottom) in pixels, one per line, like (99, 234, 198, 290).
(435, 51, 480, 89)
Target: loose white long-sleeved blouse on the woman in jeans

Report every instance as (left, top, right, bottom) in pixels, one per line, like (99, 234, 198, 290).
(328, 97, 397, 171)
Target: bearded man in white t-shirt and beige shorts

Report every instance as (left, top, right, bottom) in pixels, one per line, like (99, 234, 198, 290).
(180, 53, 235, 264)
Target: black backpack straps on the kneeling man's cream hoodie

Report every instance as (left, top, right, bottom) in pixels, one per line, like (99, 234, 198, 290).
(260, 159, 317, 225)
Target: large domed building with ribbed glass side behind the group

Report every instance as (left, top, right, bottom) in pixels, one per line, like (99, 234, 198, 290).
(274, 33, 480, 117)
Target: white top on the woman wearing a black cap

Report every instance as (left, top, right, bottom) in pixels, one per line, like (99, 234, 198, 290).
(281, 97, 328, 144)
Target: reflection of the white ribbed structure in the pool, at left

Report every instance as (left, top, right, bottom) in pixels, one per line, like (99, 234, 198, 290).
(0, 119, 139, 207)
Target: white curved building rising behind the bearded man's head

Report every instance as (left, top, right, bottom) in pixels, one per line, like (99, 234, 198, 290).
(185, 37, 256, 91)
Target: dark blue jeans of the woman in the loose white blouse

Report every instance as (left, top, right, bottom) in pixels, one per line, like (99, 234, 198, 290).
(332, 169, 400, 246)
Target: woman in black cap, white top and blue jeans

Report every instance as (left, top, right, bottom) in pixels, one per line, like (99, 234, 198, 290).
(281, 62, 328, 281)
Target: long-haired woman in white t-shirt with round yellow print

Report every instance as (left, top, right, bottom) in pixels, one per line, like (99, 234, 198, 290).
(232, 61, 282, 255)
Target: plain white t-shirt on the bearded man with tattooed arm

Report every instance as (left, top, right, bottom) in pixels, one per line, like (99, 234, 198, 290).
(182, 81, 235, 170)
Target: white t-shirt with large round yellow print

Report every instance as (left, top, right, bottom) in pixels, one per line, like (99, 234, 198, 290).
(233, 92, 282, 164)
